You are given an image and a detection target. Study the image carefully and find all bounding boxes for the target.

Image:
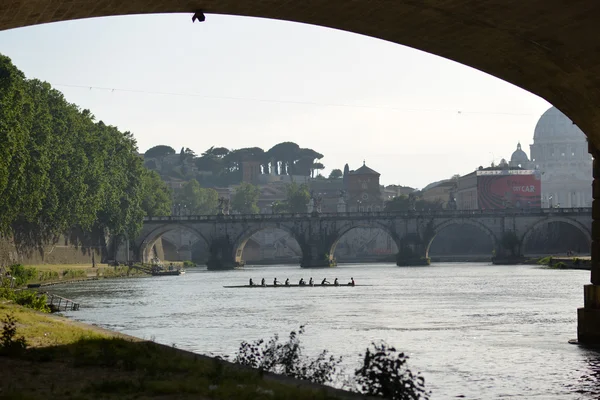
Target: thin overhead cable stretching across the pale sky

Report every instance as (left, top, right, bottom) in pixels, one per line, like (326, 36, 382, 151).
(54, 83, 538, 117)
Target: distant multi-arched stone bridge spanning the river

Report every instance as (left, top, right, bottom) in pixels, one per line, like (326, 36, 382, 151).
(118, 208, 592, 269)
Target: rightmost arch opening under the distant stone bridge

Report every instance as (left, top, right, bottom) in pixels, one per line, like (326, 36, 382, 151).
(521, 218, 592, 256)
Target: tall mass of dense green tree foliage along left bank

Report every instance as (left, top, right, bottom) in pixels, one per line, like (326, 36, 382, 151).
(0, 56, 152, 251)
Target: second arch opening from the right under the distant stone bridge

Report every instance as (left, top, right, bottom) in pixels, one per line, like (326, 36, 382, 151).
(427, 222, 494, 262)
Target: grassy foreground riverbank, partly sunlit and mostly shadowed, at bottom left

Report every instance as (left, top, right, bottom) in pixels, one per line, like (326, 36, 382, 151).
(0, 302, 362, 400)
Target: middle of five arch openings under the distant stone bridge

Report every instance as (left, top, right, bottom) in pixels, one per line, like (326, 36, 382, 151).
(330, 226, 398, 263)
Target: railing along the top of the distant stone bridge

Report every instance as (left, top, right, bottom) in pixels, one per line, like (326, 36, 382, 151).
(144, 207, 592, 222)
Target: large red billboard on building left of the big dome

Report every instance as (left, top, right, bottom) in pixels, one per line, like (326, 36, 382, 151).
(477, 170, 542, 210)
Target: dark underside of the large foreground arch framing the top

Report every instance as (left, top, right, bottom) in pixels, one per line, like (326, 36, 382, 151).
(0, 0, 600, 148)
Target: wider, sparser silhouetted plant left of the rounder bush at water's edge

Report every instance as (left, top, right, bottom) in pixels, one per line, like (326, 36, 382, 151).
(234, 326, 342, 384)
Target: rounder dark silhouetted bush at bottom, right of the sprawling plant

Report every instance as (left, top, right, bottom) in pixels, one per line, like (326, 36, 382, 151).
(355, 342, 429, 400)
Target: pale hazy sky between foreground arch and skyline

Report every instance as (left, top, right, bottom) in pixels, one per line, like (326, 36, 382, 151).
(0, 14, 550, 188)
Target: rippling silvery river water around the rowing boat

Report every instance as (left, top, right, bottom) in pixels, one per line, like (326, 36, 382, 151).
(50, 263, 600, 399)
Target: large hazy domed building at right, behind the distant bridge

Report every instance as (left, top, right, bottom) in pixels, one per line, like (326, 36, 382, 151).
(528, 107, 592, 207)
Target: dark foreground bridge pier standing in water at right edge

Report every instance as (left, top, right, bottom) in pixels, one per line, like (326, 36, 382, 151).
(577, 143, 600, 345)
